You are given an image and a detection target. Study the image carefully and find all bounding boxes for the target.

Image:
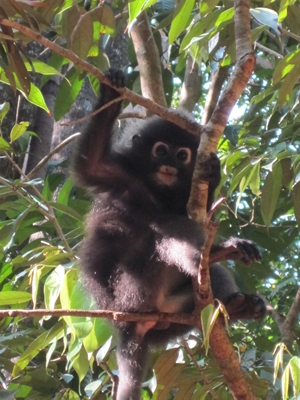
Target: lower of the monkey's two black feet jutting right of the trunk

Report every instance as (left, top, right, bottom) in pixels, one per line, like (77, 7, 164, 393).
(224, 292, 266, 322)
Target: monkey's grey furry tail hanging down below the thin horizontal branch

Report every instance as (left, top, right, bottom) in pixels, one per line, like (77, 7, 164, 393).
(117, 324, 148, 400)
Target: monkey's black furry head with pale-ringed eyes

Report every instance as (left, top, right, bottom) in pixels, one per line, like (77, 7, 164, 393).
(130, 117, 199, 209)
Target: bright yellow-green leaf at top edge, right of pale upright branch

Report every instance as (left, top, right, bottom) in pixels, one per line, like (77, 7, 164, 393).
(169, 0, 195, 44)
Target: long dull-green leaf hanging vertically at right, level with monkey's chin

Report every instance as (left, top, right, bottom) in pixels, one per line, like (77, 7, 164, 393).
(261, 163, 282, 227)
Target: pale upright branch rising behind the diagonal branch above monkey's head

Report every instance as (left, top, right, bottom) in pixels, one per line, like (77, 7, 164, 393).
(130, 11, 167, 107)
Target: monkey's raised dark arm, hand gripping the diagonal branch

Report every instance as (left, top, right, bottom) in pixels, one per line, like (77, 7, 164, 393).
(73, 69, 125, 187)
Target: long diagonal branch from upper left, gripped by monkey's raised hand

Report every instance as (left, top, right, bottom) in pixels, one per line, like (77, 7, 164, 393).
(0, 18, 202, 135)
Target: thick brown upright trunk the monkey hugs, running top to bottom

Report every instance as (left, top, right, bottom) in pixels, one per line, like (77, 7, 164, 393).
(188, 0, 255, 400)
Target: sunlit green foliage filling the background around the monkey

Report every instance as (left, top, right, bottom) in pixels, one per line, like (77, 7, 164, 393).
(0, 0, 300, 400)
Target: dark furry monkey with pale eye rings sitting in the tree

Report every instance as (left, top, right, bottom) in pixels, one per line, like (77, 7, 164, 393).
(73, 69, 265, 400)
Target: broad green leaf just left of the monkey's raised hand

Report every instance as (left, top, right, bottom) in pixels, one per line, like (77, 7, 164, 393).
(54, 67, 84, 121)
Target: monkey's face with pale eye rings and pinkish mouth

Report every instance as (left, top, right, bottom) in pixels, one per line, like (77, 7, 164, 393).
(150, 142, 193, 186)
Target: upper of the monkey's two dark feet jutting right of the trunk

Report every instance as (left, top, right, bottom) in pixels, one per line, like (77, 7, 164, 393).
(209, 237, 261, 265)
